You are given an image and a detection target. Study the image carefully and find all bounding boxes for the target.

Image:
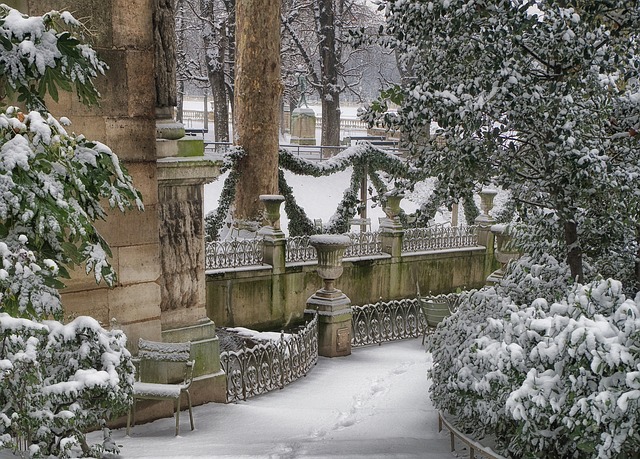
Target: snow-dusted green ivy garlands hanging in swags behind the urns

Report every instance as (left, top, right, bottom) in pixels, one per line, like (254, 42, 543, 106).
(205, 144, 478, 241)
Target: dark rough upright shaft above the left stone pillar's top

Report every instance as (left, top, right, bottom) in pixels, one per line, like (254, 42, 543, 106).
(153, 0, 176, 107)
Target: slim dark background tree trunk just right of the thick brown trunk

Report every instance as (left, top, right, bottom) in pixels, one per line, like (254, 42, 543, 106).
(316, 0, 340, 150)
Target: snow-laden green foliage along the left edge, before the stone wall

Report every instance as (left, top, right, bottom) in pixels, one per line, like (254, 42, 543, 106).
(0, 5, 142, 457)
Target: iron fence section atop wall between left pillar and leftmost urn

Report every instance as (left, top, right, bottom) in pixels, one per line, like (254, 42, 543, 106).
(205, 238, 262, 269)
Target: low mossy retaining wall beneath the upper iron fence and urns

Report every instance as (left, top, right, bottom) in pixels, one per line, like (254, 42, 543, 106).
(207, 247, 493, 330)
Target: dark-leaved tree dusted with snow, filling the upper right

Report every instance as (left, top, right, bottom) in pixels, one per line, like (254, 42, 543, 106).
(366, 0, 640, 279)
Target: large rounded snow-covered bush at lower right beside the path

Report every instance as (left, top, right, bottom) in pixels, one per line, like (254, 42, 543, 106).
(429, 270, 640, 458)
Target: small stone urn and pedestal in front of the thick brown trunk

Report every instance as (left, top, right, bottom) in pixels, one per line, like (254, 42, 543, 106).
(258, 194, 287, 274)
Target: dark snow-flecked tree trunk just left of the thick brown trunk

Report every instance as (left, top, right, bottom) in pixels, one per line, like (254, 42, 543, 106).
(200, 0, 229, 142)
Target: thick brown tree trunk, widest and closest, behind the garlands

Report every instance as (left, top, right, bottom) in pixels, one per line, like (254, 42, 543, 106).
(234, 0, 282, 222)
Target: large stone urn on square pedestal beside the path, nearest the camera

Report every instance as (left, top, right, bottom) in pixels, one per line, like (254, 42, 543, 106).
(305, 235, 353, 357)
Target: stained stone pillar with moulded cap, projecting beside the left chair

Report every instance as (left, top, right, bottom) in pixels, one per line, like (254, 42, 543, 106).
(157, 151, 226, 403)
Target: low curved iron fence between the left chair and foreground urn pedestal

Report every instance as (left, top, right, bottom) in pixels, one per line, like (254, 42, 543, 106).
(220, 316, 318, 403)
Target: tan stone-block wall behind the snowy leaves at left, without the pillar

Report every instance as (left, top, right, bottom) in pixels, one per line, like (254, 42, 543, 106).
(20, 0, 162, 350)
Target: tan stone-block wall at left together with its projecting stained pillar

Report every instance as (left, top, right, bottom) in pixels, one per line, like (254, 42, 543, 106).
(10, 0, 225, 420)
